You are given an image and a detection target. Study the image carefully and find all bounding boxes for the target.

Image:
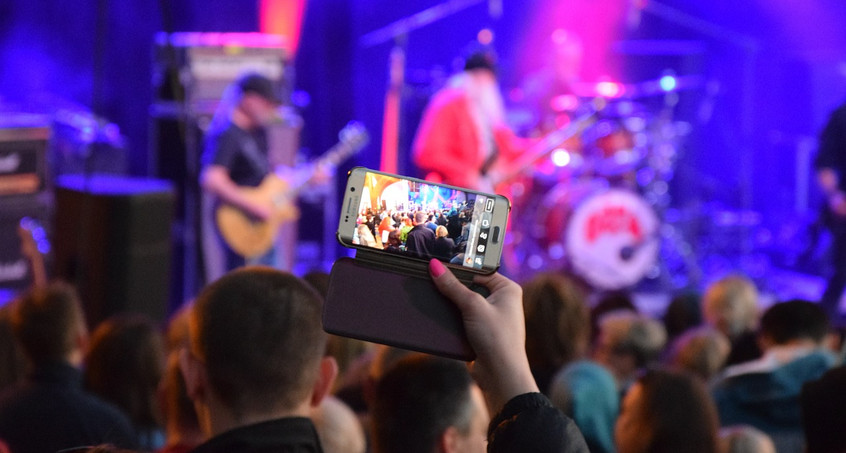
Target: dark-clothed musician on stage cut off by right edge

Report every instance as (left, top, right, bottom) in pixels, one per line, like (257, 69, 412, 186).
(814, 100, 846, 325)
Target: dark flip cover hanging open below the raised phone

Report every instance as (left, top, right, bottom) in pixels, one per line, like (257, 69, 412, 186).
(323, 254, 476, 361)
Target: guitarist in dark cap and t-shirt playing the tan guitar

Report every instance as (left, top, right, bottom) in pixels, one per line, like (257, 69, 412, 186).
(200, 74, 314, 278)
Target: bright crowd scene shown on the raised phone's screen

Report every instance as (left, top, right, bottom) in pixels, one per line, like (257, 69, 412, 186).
(353, 202, 474, 264)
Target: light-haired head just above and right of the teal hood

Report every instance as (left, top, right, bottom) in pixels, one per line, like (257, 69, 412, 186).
(594, 310, 667, 386)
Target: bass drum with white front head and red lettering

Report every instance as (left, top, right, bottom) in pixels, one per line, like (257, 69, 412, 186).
(539, 185, 660, 290)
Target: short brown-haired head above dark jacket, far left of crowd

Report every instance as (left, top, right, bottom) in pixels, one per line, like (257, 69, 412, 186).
(11, 283, 88, 366)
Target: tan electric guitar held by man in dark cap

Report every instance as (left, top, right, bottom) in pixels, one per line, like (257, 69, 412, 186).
(215, 121, 370, 258)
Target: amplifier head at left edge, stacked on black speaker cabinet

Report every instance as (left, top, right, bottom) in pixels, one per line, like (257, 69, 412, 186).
(0, 123, 50, 195)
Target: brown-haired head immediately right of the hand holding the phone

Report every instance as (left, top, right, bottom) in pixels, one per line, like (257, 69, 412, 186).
(523, 273, 590, 369)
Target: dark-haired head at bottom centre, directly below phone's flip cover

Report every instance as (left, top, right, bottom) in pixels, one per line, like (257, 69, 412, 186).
(371, 354, 490, 453)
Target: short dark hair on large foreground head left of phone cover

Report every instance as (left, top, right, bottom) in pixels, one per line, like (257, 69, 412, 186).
(190, 267, 326, 414)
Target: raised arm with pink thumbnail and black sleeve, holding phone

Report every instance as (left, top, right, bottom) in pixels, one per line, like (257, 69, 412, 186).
(429, 260, 588, 453)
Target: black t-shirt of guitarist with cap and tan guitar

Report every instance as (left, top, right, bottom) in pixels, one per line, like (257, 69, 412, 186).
(203, 123, 270, 187)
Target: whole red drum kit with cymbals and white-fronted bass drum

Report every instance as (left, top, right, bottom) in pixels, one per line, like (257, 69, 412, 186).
(505, 88, 699, 290)
